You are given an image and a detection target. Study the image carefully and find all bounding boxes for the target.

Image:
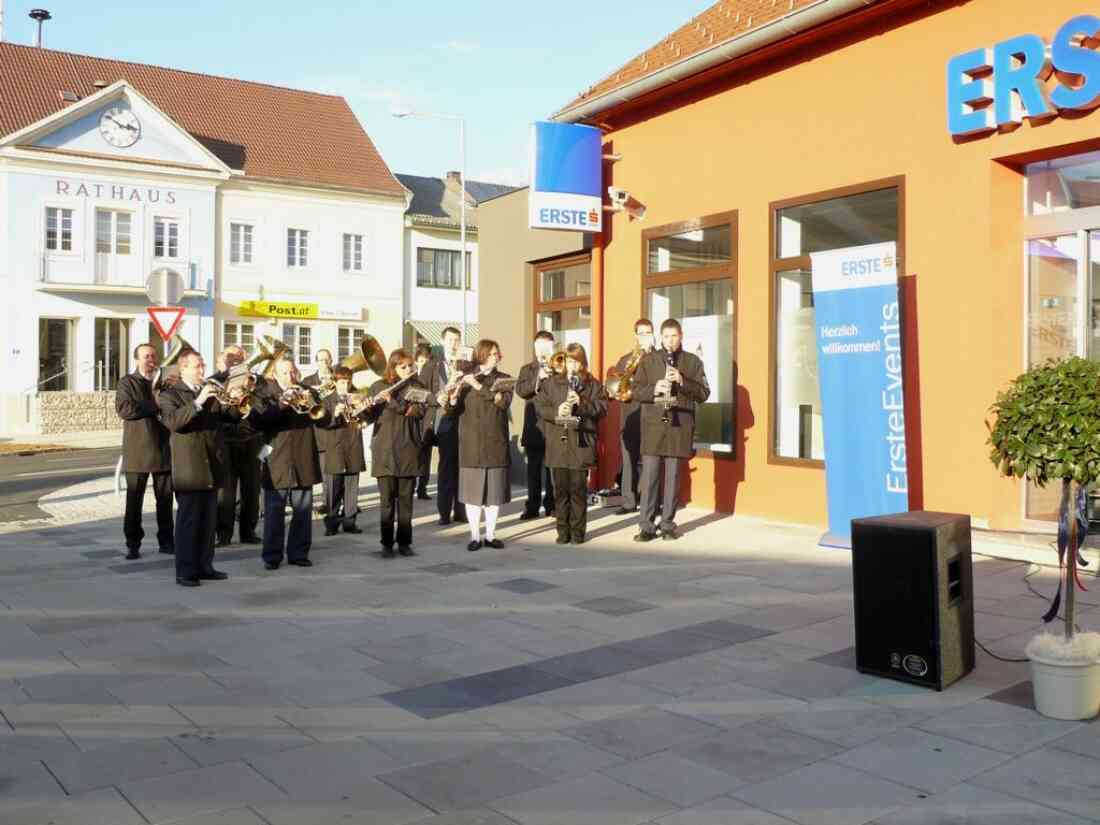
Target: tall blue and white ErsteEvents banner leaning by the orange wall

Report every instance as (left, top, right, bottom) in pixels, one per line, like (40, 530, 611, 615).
(811, 242, 909, 548)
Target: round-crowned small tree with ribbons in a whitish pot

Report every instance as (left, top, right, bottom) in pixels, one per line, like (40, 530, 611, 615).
(986, 358, 1100, 719)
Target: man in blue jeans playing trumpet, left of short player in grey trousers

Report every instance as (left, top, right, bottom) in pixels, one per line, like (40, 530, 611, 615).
(252, 358, 321, 570)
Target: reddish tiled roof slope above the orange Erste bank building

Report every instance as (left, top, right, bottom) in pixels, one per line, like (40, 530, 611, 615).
(558, 0, 840, 114)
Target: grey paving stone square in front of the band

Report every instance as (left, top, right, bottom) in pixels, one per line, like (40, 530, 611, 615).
(0, 482, 1100, 825)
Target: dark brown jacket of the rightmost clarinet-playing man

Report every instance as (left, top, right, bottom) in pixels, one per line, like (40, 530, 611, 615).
(634, 349, 711, 459)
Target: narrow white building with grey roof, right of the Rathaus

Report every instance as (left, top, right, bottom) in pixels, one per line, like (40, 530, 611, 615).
(397, 172, 515, 348)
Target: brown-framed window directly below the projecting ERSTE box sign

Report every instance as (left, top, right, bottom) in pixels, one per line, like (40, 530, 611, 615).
(535, 255, 592, 359)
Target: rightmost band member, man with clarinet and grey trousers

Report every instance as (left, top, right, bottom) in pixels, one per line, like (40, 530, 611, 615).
(634, 318, 711, 541)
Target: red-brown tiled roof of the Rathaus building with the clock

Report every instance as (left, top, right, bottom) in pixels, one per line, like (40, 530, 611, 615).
(0, 43, 405, 197)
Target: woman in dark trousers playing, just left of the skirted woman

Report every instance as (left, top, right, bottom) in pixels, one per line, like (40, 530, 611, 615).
(367, 350, 426, 559)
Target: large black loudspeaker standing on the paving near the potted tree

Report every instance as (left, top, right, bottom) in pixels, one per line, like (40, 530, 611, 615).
(851, 510, 974, 691)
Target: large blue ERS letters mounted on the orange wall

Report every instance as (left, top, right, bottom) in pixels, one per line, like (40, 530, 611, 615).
(947, 14, 1100, 138)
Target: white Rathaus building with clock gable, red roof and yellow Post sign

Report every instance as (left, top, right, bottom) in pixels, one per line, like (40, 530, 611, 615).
(0, 43, 409, 433)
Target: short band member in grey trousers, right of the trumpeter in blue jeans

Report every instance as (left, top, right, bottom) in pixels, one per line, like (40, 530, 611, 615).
(317, 366, 366, 536)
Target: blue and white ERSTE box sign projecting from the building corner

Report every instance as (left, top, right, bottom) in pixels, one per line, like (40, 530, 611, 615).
(528, 122, 604, 232)
